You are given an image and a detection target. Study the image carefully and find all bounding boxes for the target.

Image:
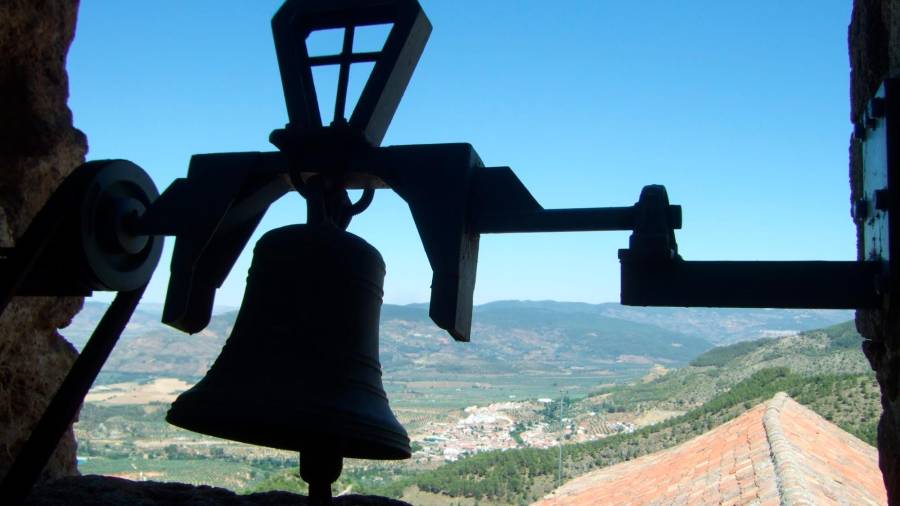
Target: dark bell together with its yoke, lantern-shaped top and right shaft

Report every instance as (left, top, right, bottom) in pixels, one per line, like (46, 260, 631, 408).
(160, 0, 678, 499)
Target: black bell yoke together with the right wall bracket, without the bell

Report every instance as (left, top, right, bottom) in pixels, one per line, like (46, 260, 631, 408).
(134, 0, 895, 341)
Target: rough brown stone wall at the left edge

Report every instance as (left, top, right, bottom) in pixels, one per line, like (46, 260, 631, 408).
(0, 0, 87, 479)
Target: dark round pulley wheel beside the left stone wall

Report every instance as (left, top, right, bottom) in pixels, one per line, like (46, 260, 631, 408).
(73, 160, 163, 291)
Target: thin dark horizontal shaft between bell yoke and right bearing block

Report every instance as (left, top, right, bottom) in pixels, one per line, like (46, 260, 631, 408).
(473, 206, 681, 234)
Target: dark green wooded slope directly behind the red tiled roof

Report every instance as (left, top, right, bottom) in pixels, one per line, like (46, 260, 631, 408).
(364, 367, 875, 504)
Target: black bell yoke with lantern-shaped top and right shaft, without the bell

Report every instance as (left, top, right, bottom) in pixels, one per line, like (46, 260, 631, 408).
(138, 0, 681, 341)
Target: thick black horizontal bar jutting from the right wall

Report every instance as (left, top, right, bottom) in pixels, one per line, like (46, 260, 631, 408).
(621, 258, 882, 309)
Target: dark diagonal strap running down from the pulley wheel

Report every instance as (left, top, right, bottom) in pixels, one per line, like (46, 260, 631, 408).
(0, 285, 146, 506)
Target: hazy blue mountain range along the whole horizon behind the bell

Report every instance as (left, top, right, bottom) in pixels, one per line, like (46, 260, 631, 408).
(63, 301, 851, 377)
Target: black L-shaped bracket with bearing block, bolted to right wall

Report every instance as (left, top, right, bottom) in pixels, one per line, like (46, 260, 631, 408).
(619, 79, 900, 309)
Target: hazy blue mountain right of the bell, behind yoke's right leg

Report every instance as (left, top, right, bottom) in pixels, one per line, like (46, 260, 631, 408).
(381, 303, 711, 374)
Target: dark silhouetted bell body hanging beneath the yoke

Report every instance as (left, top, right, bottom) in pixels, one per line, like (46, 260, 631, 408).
(166, 225, 410, 462)
